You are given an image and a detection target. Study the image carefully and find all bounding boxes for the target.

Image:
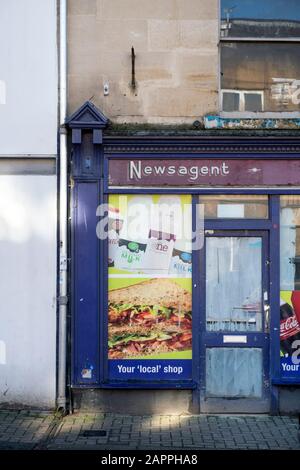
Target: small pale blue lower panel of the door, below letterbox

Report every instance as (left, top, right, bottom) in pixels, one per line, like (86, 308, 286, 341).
(206, 348, 263, 398)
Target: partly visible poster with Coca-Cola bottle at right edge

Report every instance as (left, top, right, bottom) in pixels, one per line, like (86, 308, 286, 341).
(280, 290, 300, 378)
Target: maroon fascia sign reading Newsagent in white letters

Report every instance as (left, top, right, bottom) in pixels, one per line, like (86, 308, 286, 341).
(108, 157, 300, 186)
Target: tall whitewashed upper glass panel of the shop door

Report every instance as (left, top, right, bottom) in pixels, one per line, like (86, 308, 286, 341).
(206, 237, 262, 331)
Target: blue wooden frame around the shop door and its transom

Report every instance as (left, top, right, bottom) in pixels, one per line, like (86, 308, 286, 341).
(193, 196, 282, 413)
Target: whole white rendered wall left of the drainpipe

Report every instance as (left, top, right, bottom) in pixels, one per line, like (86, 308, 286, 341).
(0, 0, 58, 408)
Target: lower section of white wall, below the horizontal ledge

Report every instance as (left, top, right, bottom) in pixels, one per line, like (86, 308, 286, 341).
(0, 175, 56, 408)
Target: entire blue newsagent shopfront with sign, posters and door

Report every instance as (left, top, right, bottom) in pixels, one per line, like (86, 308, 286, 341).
(69, 103, 300, 413)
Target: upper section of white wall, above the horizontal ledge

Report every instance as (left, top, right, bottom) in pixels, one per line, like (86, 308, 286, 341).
(0, 0, 58, 156)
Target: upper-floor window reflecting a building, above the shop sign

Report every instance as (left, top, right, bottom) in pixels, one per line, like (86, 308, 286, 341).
(220, 0, 300, 113)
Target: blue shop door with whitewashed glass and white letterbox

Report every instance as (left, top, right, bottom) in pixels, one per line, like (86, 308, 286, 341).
(200, 230, 270, 413)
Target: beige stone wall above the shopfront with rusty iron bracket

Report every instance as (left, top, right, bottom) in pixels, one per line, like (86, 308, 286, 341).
(68, 0, 218, 123)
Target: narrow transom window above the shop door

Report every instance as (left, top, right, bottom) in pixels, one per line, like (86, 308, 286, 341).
(199, 195, 268, 219)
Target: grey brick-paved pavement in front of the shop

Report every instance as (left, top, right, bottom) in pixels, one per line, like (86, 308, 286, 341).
(0, 410, 300, 450)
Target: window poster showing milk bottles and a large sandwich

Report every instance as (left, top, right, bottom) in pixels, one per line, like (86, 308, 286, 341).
(108, 195, 192, 381)
